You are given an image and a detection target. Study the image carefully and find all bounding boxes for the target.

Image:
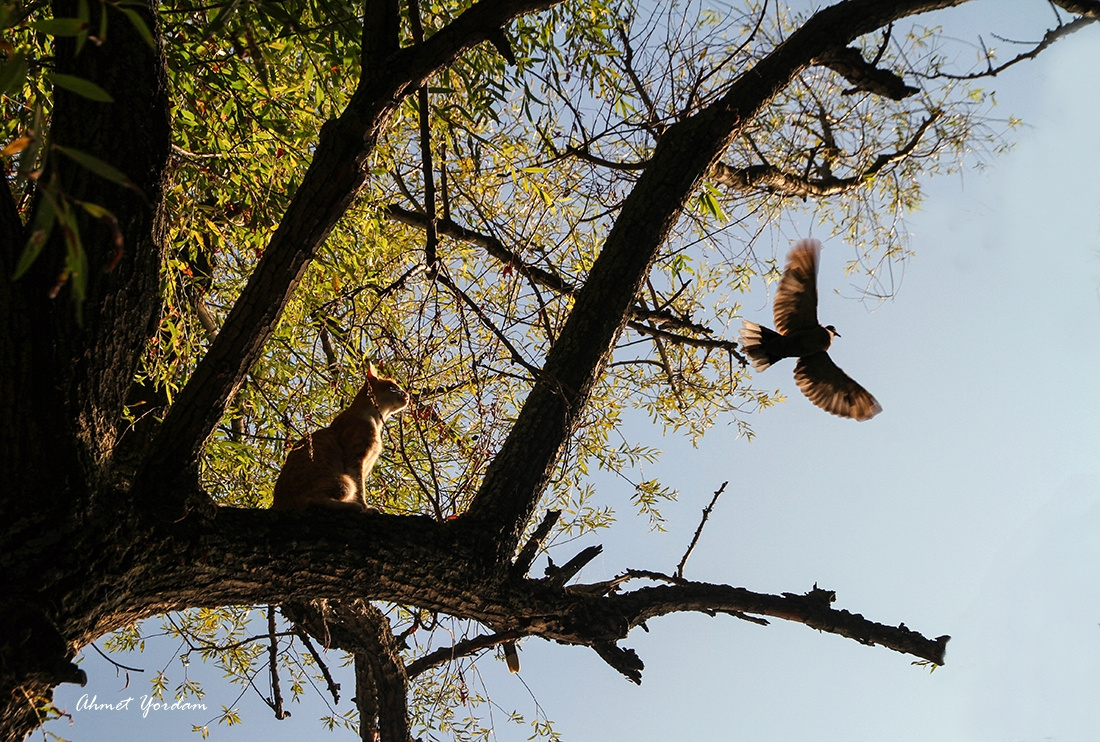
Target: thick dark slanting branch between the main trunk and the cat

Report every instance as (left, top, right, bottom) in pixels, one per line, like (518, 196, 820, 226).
(136, 0, 561, 518)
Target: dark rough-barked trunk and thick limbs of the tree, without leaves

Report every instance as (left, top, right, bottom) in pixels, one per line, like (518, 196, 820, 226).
(0, 0, 1097, 740)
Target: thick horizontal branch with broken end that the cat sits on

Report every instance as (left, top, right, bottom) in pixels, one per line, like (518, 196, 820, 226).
(73, 508, 947, 693)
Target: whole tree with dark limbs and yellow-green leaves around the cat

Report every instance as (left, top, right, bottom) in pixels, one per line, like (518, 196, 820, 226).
(0, 0, 1100, 740)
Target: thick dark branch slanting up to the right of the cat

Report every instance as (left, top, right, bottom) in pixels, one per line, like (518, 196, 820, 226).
(459, 0, 964, 558)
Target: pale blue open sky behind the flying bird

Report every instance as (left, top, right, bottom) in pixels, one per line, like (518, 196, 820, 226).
(54, 0, 1100, 742)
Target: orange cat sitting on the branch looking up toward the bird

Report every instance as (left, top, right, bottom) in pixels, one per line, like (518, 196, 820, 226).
(272, 364, 409, 512)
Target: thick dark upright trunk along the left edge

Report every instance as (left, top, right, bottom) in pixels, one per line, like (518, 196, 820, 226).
(0, 1, 171, 739)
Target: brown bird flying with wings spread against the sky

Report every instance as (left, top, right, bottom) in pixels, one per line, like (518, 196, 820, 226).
(741, 240, 882, 420)
